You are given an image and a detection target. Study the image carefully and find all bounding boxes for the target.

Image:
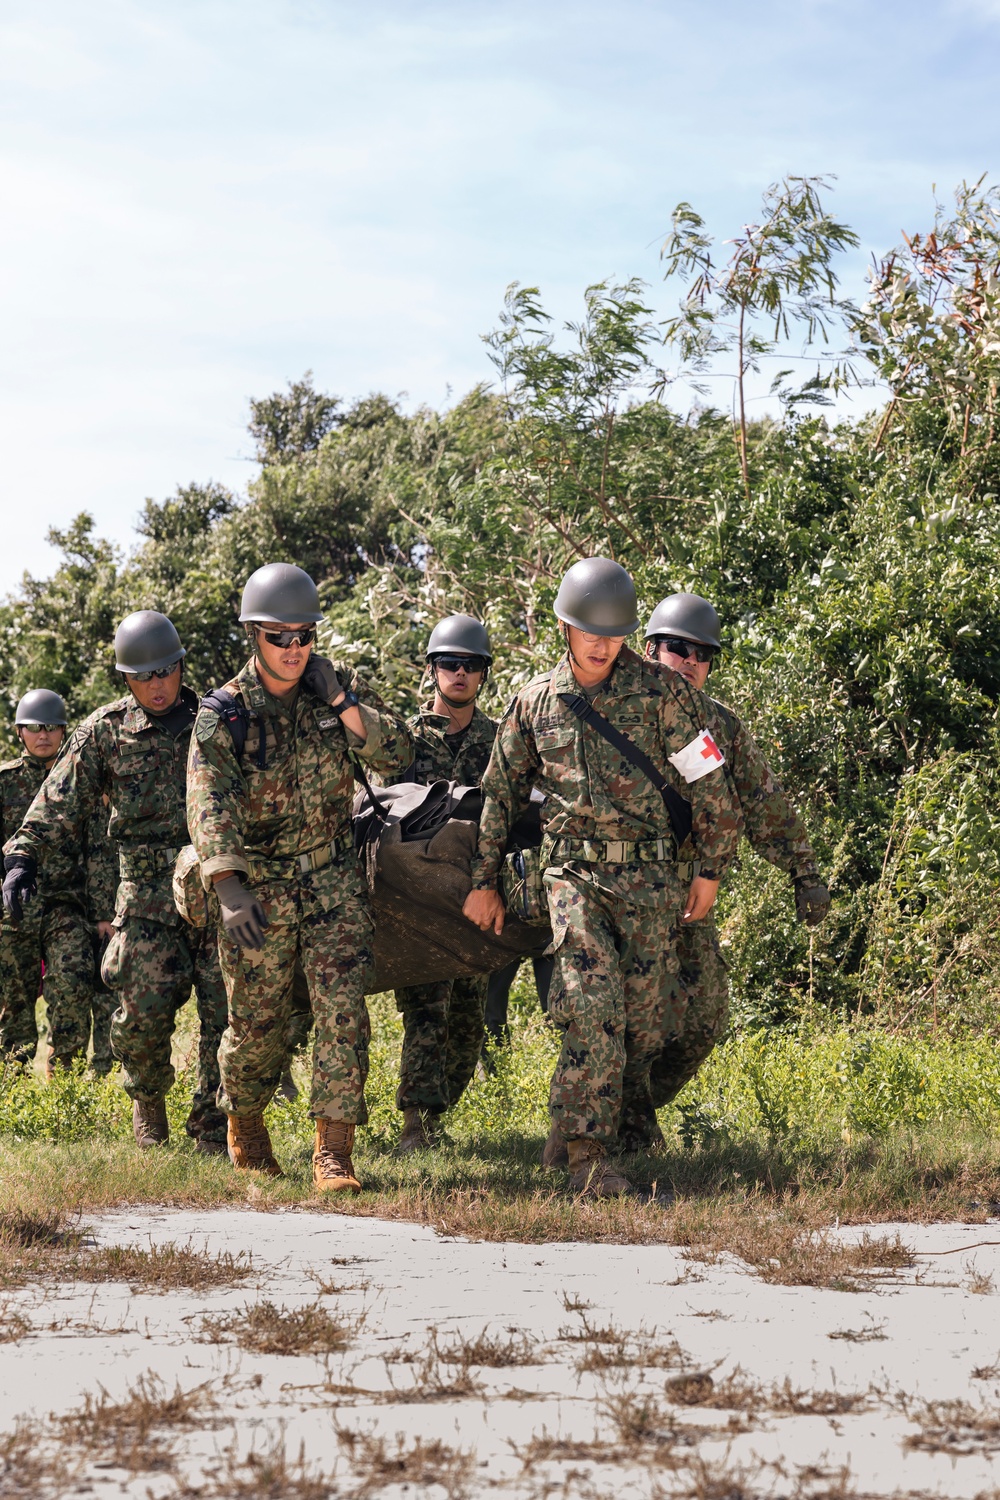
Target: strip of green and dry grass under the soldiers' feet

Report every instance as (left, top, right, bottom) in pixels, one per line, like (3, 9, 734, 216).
(0, 972, 1000, 1254)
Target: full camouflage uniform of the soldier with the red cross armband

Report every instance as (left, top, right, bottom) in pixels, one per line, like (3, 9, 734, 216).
(472, 647, 738, 1145)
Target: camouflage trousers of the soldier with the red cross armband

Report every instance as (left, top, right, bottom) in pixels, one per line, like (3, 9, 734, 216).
(546, 866, 687, 1146)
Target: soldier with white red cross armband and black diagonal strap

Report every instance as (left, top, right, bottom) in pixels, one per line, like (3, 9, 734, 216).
(465, 558, 736, 1196)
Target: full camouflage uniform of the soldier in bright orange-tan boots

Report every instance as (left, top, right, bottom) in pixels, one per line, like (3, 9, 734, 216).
(187, 660, 412, 1124)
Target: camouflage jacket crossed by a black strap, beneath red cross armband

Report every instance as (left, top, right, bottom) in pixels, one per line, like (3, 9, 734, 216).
(472, 647, 739, 890)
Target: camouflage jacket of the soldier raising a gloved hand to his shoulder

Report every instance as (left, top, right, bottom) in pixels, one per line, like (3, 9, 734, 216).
(187, 659, 414, 884)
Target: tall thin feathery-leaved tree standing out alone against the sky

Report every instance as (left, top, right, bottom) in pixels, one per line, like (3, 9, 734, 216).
(660, 177, 859, 500)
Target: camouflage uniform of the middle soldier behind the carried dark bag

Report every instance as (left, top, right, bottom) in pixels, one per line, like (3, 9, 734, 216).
(396, 699, 496, 1113)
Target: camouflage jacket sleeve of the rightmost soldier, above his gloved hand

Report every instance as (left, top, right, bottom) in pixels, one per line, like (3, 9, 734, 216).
(695, 696, 819, 878)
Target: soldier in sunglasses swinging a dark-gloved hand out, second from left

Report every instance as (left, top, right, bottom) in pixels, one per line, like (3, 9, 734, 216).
(3, 609, 225, 1155)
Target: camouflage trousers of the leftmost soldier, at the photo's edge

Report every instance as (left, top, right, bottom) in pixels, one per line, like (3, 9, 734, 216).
(0, 906, 97, 1064)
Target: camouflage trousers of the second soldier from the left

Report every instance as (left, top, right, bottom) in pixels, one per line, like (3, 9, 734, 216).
(100, 917, 226, 1140)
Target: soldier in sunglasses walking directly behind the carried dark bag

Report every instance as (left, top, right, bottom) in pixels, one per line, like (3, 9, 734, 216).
(396, 615, 496, 1155)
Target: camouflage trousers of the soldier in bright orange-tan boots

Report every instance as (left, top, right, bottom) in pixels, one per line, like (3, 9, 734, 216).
(219, 854, 375, 1125)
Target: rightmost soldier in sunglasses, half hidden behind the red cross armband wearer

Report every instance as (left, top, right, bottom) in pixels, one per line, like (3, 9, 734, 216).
(619, 594, 831, 1151)
